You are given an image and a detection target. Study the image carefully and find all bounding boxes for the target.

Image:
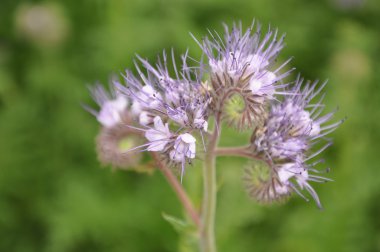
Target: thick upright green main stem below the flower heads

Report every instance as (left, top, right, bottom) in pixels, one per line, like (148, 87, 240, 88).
(200, 120, 220, 252)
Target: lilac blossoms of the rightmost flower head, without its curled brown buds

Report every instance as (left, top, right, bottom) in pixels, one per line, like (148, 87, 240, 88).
(248, 78, 344, 207)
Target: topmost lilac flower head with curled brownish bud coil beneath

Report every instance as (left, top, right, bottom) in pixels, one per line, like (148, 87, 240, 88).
(193, 20, 292, 129)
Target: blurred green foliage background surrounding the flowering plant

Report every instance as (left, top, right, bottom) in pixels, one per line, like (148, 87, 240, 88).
(0, 0, 380, 252)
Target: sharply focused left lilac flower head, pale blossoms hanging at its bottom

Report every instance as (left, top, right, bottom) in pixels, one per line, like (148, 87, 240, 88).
(111, 52, 211, 181)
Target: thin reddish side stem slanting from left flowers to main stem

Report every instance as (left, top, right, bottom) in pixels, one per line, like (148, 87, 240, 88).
(152, 152, 201, 229)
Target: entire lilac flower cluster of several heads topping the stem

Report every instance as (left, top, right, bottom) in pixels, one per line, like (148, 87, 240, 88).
(89, 21, 341, 206)
